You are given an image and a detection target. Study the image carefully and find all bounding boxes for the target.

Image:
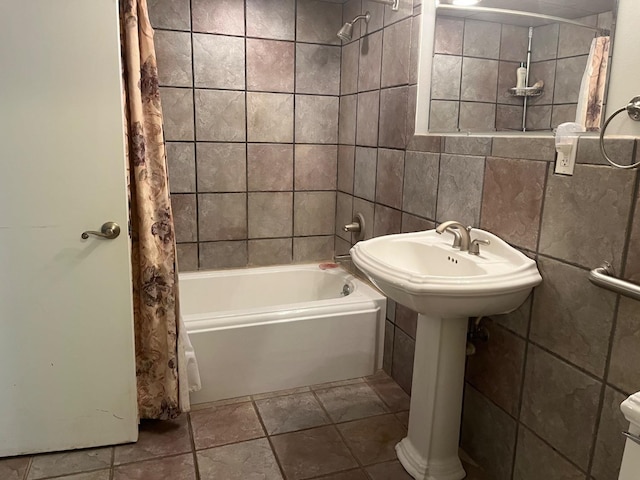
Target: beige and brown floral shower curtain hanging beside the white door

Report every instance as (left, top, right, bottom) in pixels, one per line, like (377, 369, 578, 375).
(120, 0, 182, 419)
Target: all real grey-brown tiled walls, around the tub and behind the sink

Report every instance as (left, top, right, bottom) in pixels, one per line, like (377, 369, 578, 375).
(150, 0, 640, 480)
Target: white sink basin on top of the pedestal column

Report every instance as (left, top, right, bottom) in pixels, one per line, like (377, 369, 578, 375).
(351, 229, 542, 318)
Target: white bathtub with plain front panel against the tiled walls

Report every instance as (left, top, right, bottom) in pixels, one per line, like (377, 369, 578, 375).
(180, 264, 386, 404)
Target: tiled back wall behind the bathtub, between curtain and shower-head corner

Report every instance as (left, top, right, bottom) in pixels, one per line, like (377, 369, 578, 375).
(149, 0, 342, 271)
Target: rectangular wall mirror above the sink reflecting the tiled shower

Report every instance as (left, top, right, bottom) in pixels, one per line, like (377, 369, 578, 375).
(418, 0, 617, 133)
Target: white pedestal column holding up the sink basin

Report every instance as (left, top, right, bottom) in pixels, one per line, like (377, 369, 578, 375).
(396, 314, 468, 480)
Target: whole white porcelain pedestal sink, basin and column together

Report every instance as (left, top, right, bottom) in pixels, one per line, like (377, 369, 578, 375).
(351, 229, 542, 480)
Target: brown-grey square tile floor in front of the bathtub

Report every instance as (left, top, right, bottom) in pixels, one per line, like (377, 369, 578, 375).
(0, 372, 487, 480)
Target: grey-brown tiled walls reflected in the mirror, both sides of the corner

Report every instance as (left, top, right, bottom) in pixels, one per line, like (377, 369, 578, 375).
(429, 12, 612, 132)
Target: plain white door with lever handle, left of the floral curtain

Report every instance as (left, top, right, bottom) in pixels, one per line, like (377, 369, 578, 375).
(0, 0, 137, 457)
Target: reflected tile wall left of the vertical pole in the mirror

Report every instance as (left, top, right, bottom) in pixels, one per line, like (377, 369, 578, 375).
(429, 16, 529, 132)
